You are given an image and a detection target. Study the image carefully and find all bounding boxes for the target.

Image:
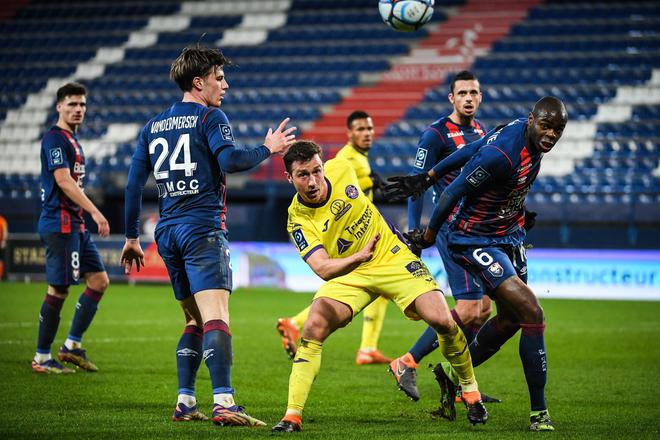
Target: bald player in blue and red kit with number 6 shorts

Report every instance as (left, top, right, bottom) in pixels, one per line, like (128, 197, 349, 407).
(388, 96, 568, 431)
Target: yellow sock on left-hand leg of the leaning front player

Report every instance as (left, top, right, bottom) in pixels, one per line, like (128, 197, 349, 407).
(287, 339, 323, 414)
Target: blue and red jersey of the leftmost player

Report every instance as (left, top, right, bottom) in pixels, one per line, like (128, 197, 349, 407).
(38, 125, 85, 234)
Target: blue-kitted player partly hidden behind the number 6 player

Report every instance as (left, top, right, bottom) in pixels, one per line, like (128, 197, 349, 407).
(388, 70, 493, 402)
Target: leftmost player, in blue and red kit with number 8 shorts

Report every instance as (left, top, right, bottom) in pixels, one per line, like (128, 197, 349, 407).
(32, 83, 110, 373)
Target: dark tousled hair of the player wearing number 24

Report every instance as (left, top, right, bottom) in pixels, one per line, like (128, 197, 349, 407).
(170, 44, 231, 92)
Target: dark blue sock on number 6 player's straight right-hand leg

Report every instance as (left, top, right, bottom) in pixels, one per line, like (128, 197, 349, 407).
(519, 324, 548, 411)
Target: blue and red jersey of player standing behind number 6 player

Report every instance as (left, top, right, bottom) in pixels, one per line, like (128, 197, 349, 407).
(408, 116, 488, 229)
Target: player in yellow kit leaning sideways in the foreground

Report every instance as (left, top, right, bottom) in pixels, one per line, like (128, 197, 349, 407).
(273, 141, 488, 432)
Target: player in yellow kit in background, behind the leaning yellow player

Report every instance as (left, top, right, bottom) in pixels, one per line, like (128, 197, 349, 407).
(276, 110, 392, 365)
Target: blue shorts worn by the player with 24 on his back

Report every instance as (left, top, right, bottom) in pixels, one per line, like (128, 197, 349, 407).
(155, 223, 232, 301)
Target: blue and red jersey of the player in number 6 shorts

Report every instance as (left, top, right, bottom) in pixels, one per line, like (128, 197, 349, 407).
(448, 118, 543, 245)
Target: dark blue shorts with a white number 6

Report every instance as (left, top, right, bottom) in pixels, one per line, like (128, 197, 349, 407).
(449, 244, 527, 292)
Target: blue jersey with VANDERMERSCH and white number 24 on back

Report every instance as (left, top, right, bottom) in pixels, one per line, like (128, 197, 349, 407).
(126, 102, 234, 236)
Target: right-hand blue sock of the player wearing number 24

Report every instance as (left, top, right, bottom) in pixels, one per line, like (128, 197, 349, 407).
(202, 319, 234, 394)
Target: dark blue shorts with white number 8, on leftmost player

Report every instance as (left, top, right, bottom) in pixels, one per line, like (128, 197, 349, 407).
(40, 231, 105, 286)
